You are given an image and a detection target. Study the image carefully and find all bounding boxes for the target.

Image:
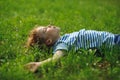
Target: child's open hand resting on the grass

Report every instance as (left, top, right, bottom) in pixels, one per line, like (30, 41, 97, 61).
(25, 62, 40, 72)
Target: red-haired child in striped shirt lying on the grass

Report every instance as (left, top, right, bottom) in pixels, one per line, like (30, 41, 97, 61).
(25, 26, 120, 72)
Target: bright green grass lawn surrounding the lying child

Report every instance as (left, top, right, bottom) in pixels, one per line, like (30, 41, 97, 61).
(0, 0, 120, 80)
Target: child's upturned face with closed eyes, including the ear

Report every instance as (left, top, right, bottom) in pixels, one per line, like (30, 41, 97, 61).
(37, 26, 60, 44)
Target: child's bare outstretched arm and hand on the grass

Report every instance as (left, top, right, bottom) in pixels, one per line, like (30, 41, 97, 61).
(25, 50, 65, 72)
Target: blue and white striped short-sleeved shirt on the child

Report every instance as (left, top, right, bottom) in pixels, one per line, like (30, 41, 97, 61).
(53, 29, 115, 53)
